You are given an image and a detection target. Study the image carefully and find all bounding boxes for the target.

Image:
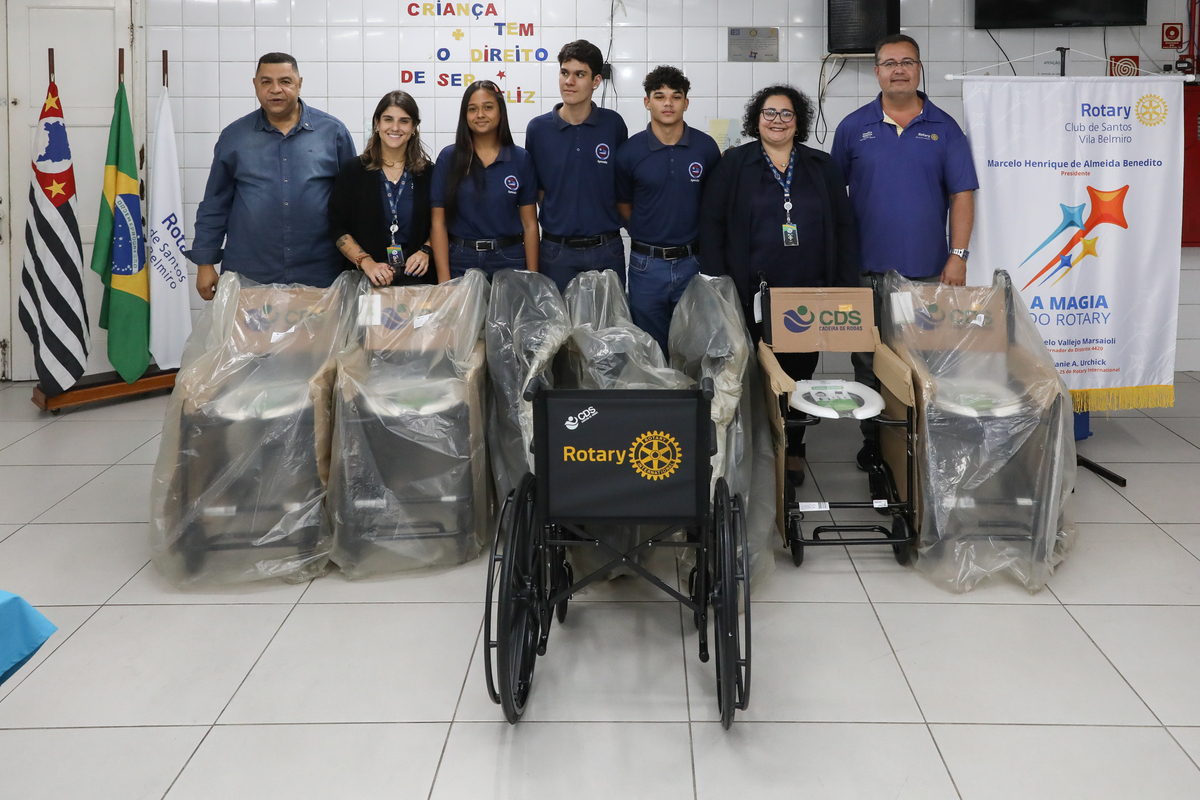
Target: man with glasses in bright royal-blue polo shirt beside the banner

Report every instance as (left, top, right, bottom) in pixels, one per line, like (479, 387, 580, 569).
(830, 34, 979, 469)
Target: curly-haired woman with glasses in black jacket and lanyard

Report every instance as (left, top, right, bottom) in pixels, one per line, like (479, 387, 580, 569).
(700, 85, 858, 485)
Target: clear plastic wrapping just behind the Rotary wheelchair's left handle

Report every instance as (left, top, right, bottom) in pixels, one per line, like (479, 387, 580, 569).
(485, 270, 571, 498)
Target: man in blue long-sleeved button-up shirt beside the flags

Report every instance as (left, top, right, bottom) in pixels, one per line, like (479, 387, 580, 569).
(187, 53, 355, 300)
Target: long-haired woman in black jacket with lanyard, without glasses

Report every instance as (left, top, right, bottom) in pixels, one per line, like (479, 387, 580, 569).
(329, 91, 434, 287)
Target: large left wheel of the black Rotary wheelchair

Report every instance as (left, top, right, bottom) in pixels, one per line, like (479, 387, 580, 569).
(496, 473, 544, 723)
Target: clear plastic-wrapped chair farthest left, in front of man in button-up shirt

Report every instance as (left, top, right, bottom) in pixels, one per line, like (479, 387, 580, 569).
(150, 272, 356, 587)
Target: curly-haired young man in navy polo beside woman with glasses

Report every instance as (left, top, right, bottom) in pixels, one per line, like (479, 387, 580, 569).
(617, 66, 721, 355)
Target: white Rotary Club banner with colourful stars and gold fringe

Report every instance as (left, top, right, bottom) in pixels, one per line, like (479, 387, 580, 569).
(962, 77, 1183, 411)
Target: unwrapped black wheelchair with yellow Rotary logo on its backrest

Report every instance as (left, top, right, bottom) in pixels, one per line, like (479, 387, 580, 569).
(484, 379, 750, 728)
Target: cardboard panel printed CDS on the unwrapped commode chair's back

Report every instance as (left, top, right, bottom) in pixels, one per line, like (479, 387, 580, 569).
(762, 288, 878, 353)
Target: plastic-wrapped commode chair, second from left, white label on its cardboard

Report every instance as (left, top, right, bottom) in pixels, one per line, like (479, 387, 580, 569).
(326, 270, 494, 578)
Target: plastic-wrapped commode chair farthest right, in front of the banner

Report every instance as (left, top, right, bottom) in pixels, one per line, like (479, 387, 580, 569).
(883, 270, 1075, 591)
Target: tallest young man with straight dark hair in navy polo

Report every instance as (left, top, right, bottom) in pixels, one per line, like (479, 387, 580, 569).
(526, 40, 629, 290)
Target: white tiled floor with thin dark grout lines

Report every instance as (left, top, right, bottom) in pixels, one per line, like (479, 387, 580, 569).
(0, 373, 1200, 800)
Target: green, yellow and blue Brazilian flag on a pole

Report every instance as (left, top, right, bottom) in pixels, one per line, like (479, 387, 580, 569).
(91, 83, 150, 384)
